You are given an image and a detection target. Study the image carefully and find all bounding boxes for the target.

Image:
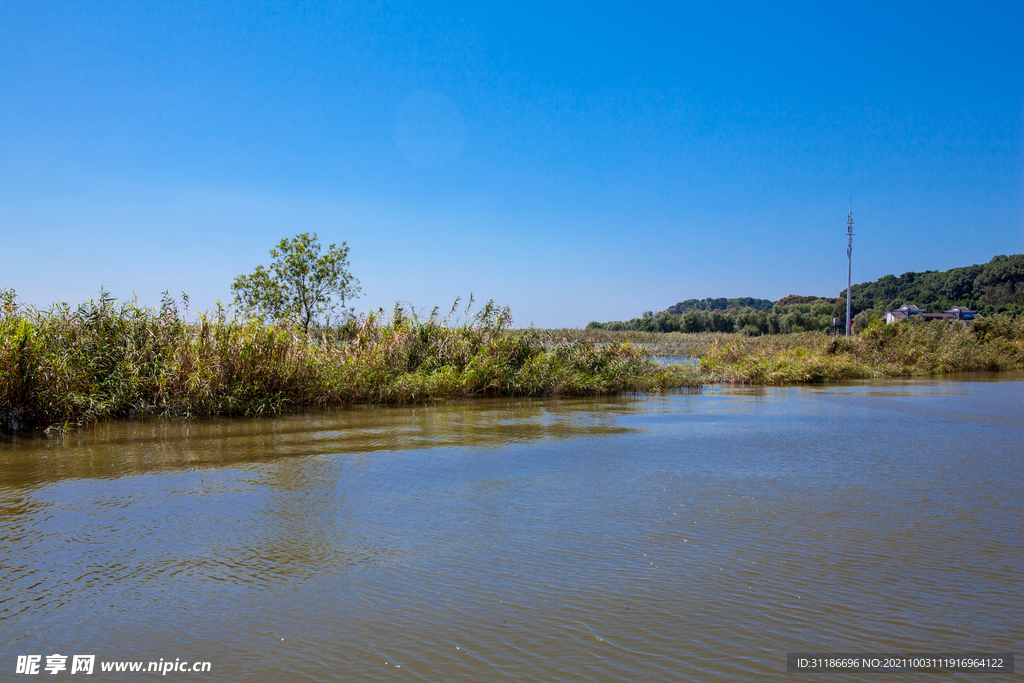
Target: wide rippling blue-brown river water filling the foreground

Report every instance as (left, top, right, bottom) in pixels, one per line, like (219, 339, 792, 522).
(0, 375, 1024, 681)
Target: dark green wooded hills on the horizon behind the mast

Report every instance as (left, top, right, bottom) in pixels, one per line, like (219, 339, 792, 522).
(587, 254, 1024, 336)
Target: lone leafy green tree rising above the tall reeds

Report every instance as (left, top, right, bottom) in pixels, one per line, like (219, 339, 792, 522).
(231, 232, 360, 332)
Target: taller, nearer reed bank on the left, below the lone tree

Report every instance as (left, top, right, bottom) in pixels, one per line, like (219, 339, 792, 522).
(0, 295, 696, 430)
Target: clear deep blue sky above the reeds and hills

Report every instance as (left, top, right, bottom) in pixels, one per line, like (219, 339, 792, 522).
(0, 0, 1024, 327)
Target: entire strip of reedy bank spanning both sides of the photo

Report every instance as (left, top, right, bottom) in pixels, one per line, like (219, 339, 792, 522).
(0, 292, 1024, 431)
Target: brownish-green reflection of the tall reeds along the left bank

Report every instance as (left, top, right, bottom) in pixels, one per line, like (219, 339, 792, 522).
(0, 399, 630, 485)
